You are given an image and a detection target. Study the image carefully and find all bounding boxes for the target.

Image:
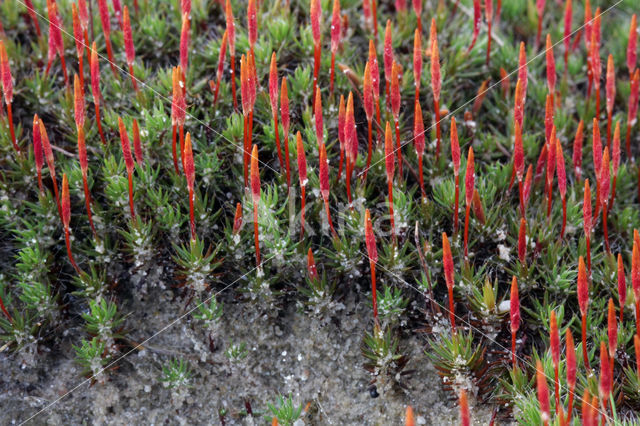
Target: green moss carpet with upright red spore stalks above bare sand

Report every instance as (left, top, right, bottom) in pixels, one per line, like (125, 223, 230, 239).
(0, 0, 640, 425)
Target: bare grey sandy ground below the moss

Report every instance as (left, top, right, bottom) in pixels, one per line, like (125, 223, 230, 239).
(0, 264, 491, 425)
